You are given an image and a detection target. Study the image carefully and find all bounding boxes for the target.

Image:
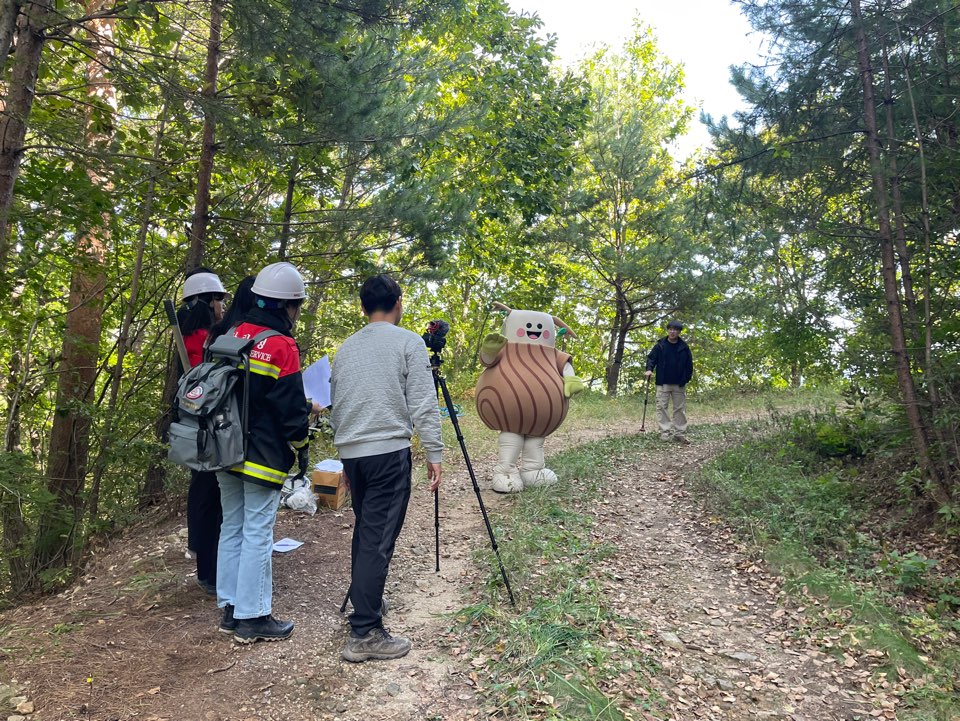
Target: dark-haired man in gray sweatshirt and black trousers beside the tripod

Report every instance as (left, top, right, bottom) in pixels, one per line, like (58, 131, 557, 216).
(330, 275, 443, 662)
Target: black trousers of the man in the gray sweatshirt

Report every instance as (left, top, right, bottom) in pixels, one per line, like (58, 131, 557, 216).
(343, 448, 410, 636)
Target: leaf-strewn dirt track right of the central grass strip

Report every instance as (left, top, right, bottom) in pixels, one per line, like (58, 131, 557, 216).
(595, 443, 895, 721)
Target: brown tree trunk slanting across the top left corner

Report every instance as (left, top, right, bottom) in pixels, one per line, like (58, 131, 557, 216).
(0, 2, 51, 282)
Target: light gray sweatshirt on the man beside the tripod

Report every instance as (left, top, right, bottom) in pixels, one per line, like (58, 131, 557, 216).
(330, 322, 443, 463)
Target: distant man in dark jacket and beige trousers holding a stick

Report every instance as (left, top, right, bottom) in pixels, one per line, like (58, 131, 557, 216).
(646, 320, 693, 444)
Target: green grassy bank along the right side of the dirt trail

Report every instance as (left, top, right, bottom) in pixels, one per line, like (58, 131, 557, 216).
(694, 417, 960, 721)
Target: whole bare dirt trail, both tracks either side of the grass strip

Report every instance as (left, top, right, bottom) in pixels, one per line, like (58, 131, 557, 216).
(0, 414, 895, 721)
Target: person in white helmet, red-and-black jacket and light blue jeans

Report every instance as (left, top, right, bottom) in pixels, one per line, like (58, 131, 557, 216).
(217, 263, 319, 643)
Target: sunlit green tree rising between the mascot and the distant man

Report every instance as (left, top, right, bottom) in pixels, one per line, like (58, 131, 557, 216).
(544, 23, 715, 395)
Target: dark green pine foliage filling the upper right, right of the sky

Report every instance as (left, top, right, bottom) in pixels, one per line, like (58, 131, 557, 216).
(701, 0, 960, 505)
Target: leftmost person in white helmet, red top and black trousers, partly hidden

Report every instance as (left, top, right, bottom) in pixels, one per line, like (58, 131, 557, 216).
(177, 267, 226, 595)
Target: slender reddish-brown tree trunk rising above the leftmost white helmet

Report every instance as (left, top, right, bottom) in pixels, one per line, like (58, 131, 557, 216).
(187, 0, 223, 270)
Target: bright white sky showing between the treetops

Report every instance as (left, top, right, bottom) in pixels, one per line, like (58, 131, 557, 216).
(507, 0, 761, 156)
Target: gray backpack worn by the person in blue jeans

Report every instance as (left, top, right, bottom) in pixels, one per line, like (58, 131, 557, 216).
(167, 330, 280, 471)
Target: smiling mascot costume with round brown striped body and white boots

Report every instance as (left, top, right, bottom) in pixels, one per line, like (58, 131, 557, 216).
(477, 303, 584, 493)
